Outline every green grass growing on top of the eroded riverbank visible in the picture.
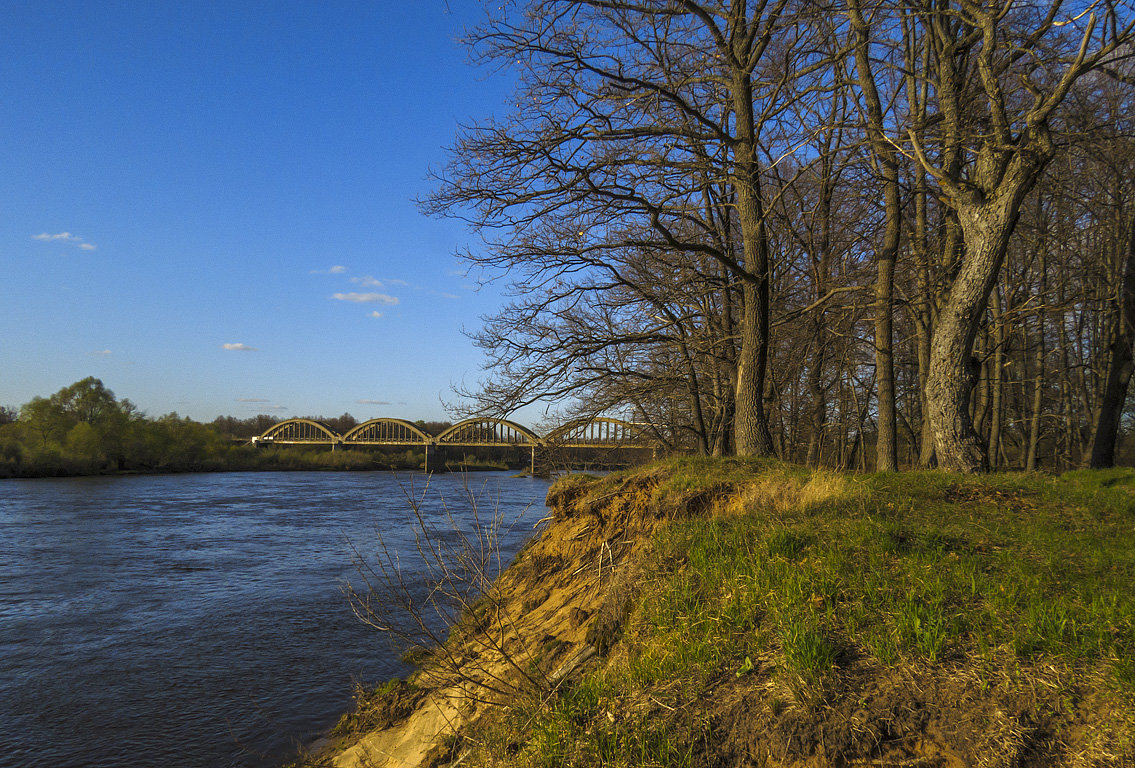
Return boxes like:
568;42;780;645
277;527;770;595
467;458;1135;767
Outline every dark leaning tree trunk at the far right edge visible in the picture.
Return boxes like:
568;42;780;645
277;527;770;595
1087;217;1135;470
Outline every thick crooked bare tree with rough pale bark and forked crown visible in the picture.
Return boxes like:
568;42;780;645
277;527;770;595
909;0;1133;472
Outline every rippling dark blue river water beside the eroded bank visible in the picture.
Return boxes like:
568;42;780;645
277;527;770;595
0;472;548;768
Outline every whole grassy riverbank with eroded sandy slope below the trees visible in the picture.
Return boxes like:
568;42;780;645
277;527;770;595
315;458;1135;767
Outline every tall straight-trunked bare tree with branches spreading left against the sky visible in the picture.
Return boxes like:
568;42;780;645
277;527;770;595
427;0;835;455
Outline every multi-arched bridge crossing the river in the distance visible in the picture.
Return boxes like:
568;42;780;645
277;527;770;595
251;416;657;472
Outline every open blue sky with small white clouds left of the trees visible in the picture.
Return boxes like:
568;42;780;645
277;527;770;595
0;0;526;420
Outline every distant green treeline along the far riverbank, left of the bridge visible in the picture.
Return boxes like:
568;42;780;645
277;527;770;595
0;377;483;478
